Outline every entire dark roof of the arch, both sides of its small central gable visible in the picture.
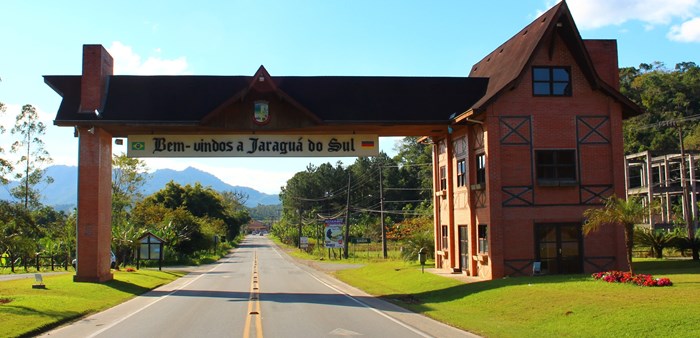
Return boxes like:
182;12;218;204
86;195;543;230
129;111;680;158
45;76;488;124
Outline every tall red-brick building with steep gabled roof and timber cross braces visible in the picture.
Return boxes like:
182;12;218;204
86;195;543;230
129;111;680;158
426;2;641;279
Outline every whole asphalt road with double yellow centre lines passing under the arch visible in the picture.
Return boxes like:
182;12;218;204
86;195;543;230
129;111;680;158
39;236;471;338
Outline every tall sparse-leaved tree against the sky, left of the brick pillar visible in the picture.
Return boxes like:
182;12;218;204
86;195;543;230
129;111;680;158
10;104;53;209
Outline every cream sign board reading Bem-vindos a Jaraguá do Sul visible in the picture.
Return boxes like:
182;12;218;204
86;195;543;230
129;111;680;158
127;135;379;157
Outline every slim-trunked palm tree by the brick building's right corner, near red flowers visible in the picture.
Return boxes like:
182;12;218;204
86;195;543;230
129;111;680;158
583;196;649;273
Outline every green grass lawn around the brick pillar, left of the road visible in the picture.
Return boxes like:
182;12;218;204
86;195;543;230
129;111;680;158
0;270;184;337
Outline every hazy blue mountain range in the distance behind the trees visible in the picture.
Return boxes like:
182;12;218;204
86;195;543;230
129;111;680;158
0;165;280;210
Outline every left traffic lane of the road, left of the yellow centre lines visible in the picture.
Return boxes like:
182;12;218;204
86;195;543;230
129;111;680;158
40;249;250;337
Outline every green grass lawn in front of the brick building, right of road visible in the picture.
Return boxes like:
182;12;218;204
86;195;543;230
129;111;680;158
336;260;700;337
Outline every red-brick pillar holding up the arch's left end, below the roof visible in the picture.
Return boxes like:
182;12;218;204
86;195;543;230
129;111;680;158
73;127;113;282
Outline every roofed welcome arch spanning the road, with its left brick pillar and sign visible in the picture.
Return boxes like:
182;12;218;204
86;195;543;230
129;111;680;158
44;45;488;282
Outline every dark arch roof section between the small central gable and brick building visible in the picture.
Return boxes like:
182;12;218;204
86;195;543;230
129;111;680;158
274;76;488;122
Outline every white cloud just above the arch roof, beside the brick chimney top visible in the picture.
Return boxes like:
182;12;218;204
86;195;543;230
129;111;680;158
107;41;190;75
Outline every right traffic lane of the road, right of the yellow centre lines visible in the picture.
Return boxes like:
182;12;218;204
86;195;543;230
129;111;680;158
256;238;430;337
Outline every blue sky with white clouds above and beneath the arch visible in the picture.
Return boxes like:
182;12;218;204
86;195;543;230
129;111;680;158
0;0;700;193
